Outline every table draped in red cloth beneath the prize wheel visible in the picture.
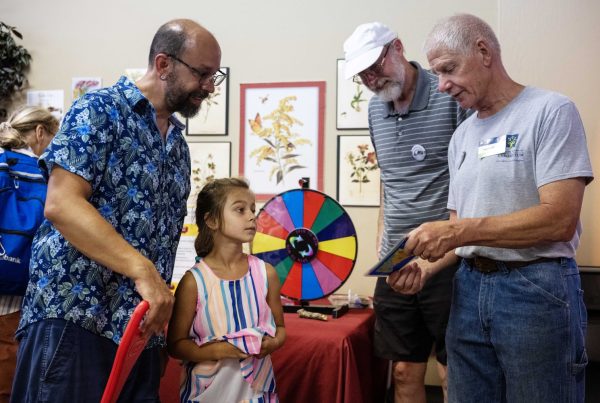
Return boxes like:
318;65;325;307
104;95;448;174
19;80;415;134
160;309;388;403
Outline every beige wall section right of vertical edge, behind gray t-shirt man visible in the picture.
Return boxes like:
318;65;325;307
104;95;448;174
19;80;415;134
498;0;600;266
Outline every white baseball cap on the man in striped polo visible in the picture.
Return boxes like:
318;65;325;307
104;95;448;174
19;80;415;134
344;22;398;79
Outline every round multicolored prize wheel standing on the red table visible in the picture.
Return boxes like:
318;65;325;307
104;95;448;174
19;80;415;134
252;189;358;301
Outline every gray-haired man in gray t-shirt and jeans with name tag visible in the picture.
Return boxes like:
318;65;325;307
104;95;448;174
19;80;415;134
390;14;593;403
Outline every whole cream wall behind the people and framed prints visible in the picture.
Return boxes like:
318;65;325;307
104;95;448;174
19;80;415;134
0;0;600;295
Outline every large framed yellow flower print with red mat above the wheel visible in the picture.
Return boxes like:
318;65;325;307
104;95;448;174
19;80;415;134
239;81;325;201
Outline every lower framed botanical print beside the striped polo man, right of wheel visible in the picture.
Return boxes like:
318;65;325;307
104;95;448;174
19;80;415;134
337;134;381;207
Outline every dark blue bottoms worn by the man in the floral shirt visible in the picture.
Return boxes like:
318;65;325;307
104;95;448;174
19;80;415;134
11;319;160;403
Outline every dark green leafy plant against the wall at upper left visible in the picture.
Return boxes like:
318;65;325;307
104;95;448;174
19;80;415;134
0;21;31;121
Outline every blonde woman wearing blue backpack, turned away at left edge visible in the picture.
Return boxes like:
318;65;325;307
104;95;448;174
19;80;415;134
0;106;59;403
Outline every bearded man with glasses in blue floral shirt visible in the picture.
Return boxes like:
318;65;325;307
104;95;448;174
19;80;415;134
12;20;224;402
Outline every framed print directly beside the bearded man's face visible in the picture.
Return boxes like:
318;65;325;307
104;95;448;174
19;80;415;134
186;67;231;136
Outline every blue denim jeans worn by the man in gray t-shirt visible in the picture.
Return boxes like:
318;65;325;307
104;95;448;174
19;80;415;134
446;258;587;403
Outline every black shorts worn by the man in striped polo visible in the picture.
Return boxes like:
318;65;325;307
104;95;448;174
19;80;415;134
373;266;458;365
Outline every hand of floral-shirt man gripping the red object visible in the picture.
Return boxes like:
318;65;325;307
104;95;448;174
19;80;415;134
132;260;175;337
